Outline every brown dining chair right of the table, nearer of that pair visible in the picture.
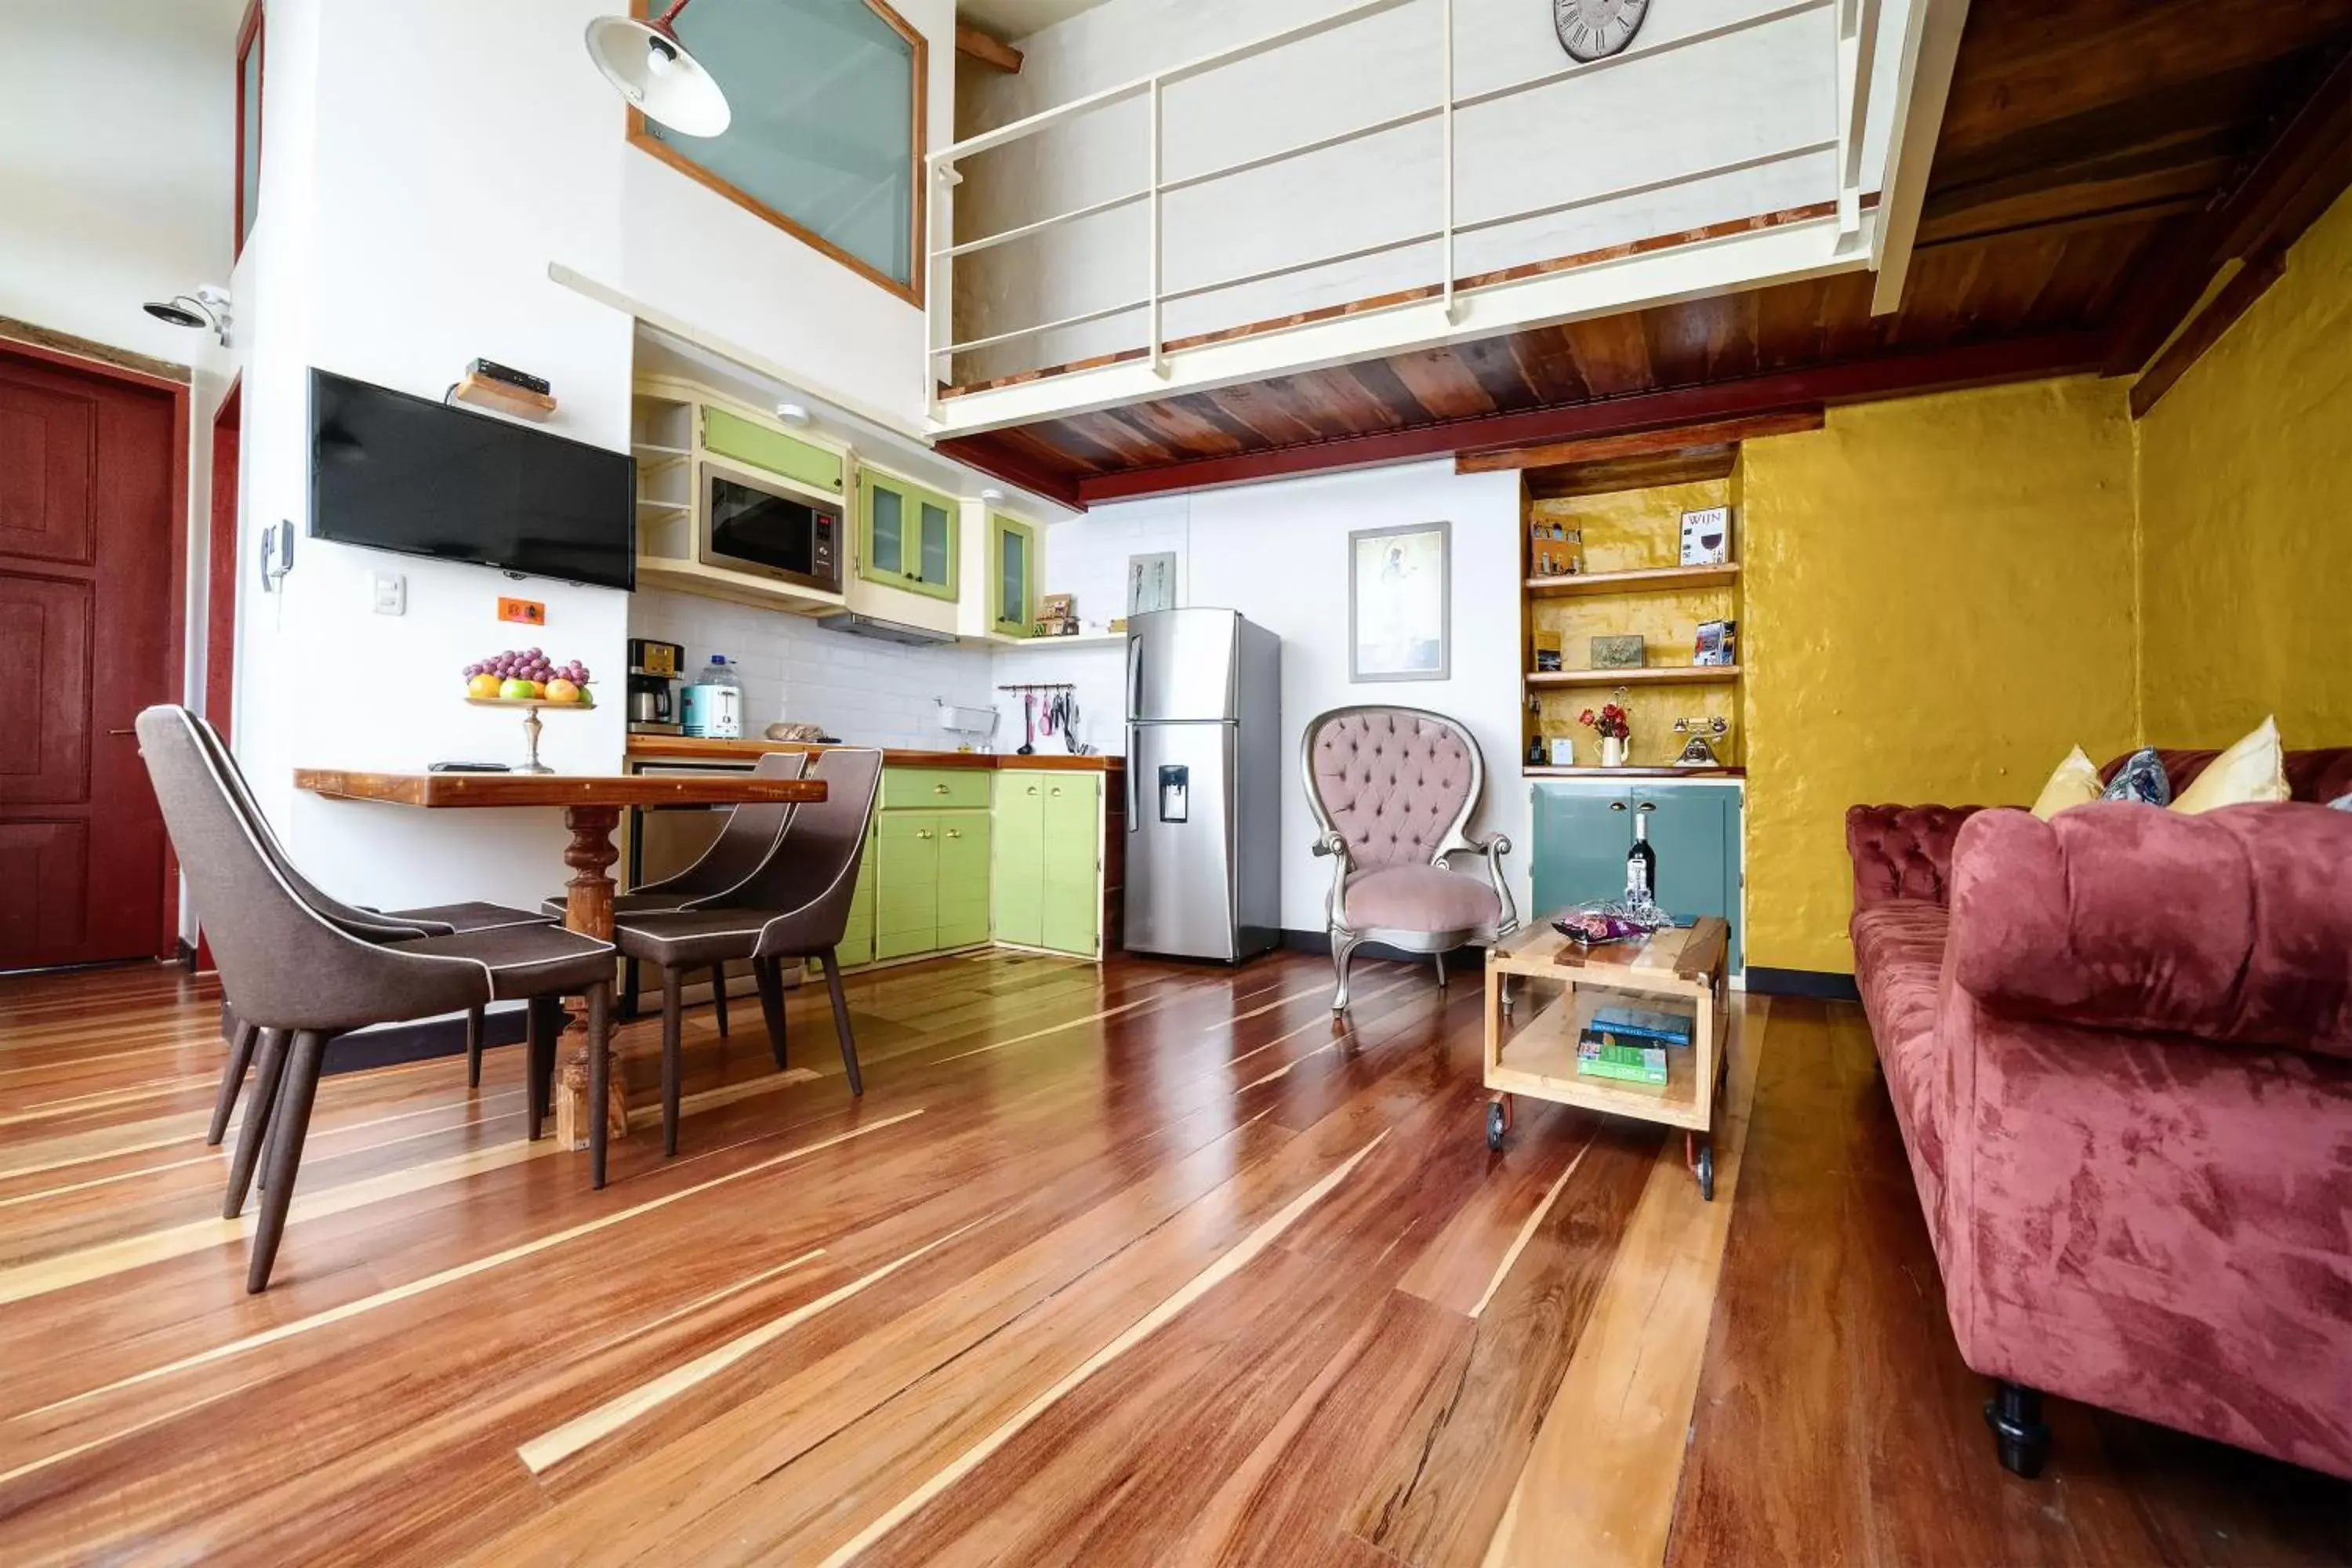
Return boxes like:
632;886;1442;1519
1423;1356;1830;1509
614;746;882;1154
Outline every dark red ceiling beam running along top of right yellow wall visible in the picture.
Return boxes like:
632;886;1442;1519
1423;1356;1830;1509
2103;49;2352;376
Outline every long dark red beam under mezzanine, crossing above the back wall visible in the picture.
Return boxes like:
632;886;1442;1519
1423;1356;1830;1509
1077;332;2105;506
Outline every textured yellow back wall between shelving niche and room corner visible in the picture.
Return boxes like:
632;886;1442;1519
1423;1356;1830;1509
1733;376;2145;971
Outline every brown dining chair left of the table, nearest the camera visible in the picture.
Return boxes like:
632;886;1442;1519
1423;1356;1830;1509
136;706;614;1293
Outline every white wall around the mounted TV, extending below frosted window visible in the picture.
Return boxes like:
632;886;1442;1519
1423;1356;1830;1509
209;0;969;931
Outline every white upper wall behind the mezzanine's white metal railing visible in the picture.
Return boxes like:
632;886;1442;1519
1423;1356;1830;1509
955;0;1905;379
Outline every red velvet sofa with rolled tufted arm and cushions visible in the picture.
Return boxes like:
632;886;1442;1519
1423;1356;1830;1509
1846;748;2352;1476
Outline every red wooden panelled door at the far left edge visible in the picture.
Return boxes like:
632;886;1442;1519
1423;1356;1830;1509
0;350;179;968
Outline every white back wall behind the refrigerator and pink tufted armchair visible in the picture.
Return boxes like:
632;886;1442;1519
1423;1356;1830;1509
995;461;1534;931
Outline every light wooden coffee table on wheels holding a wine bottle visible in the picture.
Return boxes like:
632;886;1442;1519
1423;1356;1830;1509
1486;914;1731;1203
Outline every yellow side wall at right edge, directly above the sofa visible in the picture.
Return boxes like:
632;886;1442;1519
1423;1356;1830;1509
2138;184;2352;750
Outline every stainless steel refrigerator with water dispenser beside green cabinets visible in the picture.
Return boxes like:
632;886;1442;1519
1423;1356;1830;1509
1127;609;1282;961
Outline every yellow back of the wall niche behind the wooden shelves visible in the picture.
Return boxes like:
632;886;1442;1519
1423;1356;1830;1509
1529;480;1740;767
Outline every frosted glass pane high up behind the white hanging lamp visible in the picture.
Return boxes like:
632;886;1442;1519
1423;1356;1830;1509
637;0;924;299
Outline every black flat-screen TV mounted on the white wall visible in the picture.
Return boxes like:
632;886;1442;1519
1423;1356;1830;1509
310;367;637;588
